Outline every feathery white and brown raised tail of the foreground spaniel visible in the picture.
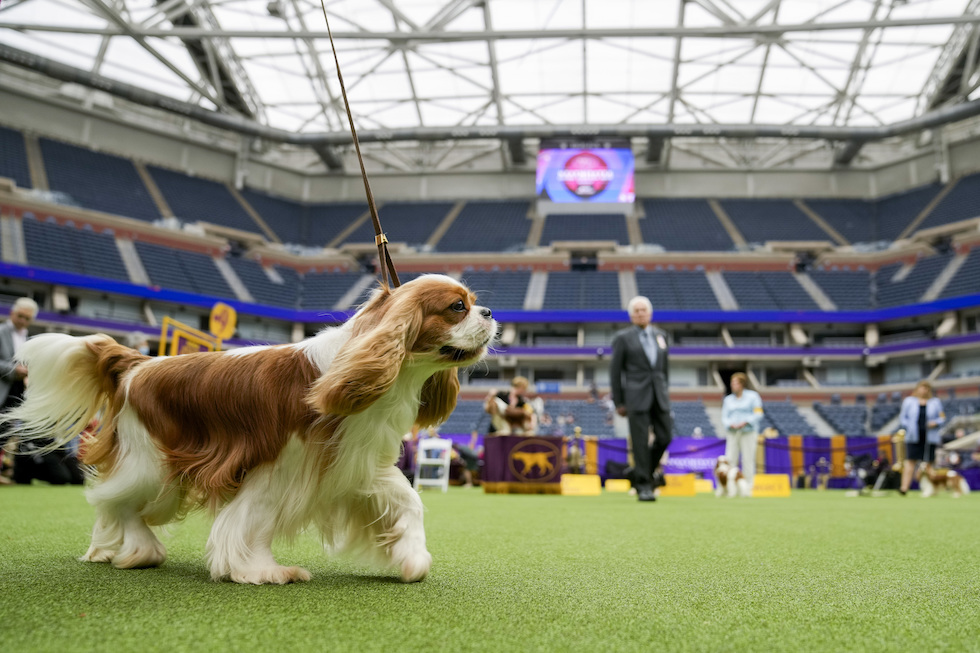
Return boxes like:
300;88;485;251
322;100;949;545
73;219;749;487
0;333;148;462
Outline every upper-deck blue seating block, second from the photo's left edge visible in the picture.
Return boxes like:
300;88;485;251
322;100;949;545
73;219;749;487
40;138;160;222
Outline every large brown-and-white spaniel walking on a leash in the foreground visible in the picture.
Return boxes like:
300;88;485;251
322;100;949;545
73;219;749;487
3;275;497;584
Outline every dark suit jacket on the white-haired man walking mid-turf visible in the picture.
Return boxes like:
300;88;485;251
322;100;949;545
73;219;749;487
609;325;670;412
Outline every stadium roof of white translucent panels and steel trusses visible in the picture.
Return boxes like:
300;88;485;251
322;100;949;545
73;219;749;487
0;0;980;173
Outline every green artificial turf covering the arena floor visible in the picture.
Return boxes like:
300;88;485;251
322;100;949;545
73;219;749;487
0;485;980;653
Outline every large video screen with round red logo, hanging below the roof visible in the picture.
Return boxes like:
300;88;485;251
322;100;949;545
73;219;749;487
536;140;636;203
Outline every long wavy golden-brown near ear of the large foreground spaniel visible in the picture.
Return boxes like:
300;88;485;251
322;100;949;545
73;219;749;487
306;292;422;415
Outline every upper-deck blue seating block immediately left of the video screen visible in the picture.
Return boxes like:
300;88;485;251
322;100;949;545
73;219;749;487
436;201;531;252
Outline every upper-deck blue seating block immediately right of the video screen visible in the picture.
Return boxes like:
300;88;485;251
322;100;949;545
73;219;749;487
639;199;735;252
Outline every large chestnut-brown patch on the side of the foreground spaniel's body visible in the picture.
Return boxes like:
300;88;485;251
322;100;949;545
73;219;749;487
129;347;322;504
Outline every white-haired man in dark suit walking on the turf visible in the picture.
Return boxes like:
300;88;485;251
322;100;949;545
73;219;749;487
609;297;673;501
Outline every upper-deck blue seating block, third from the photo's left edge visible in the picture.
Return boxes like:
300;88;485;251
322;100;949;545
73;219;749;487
146;166;262;234
